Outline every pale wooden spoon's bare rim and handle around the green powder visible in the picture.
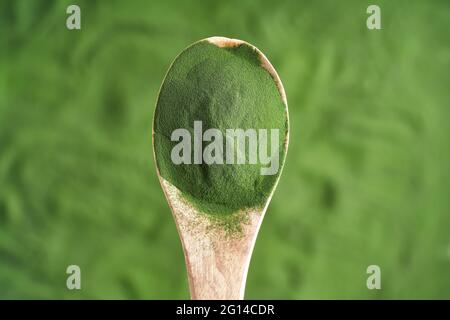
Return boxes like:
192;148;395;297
153;37;288;300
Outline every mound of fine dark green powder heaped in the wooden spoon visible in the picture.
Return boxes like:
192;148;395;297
154;41;288;219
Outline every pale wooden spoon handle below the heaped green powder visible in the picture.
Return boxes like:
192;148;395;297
174;210;262;300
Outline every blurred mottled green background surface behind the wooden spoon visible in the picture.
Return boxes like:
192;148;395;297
0;0;450;299
